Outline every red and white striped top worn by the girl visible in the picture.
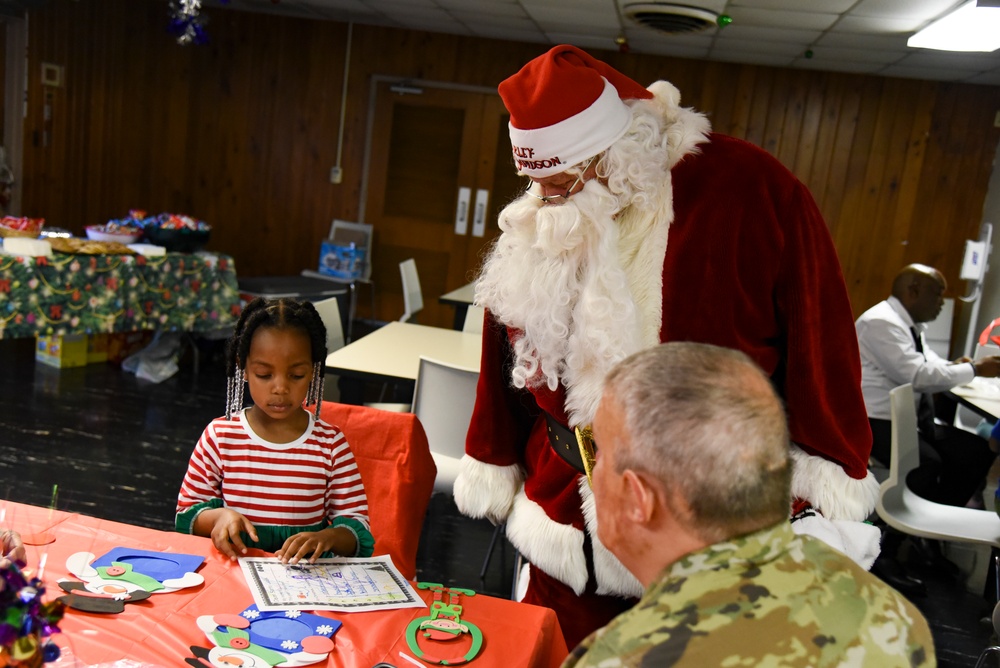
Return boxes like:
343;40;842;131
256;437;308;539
177;411;369;528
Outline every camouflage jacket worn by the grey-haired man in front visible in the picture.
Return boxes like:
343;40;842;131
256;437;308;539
563;522;937;668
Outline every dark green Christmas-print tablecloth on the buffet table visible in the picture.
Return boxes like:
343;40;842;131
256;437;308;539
0;253;240;339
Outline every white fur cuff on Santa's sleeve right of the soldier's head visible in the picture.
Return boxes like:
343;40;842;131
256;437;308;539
791;443;878;522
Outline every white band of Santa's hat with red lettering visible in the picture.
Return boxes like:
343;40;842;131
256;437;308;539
509;79;632;178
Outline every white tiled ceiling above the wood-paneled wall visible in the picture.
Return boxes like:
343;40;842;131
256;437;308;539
211;0;1000;85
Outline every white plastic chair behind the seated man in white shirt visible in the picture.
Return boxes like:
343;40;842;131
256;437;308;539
876;383;1000;548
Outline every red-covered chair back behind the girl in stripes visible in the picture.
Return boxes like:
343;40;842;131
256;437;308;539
320;401;437;580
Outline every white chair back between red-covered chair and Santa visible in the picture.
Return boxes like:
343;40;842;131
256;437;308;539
413;357;479;494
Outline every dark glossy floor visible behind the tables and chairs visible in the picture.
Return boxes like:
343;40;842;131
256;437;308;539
0;340;996;668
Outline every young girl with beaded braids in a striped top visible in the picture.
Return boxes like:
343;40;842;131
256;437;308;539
175;298;375;564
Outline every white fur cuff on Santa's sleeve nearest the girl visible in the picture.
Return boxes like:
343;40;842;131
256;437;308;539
453;455;524;524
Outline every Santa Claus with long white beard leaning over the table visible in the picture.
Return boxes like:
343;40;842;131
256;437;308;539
455;46;878;647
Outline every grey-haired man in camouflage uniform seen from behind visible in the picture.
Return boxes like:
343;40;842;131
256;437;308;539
563;343;936;668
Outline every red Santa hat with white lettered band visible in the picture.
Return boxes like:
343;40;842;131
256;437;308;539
500;45;653;178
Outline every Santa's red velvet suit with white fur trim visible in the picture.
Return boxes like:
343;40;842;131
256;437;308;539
455;47;878;647
